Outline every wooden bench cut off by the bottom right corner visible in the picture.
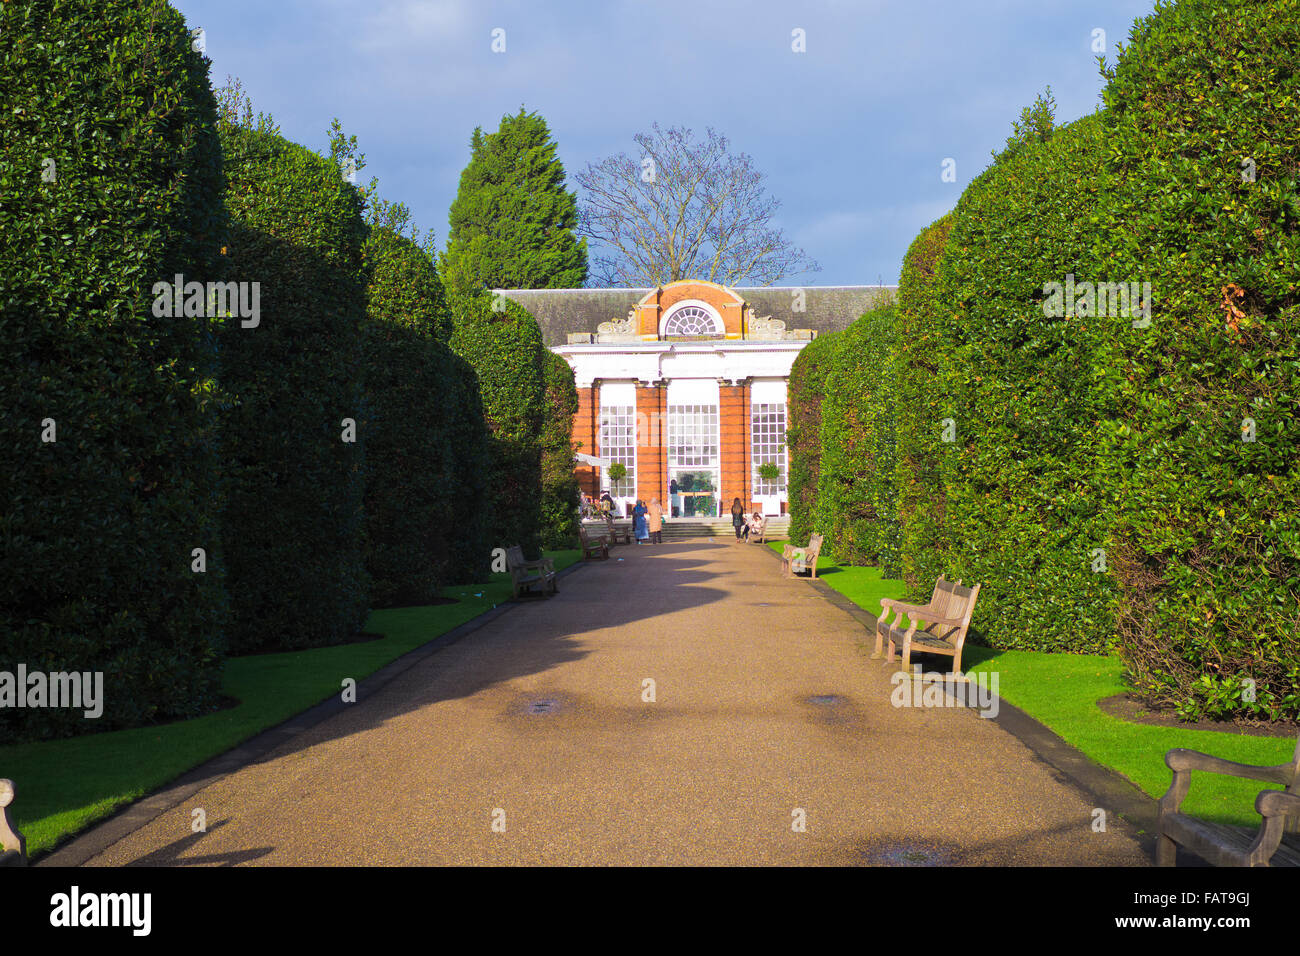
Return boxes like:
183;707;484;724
1156;739;1300;866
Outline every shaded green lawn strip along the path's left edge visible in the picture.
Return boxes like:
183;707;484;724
0;550;581;855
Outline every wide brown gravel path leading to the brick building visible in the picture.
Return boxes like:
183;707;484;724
83;540;1149;865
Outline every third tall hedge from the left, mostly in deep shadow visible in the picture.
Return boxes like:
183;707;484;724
364;226;482;607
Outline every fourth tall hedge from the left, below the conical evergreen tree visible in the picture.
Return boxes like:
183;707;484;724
450;293;546;554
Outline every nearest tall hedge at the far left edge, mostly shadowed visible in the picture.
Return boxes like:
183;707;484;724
0;0;225;739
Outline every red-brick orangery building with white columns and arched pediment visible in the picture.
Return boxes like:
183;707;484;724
499;280;896;518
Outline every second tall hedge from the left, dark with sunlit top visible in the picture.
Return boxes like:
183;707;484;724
221;124;369;652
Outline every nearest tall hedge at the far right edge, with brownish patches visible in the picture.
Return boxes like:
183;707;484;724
1104;0;1300;719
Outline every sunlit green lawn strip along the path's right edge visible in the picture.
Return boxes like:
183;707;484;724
771;541;1296;825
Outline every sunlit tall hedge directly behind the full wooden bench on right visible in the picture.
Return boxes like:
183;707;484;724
930;108;1114;653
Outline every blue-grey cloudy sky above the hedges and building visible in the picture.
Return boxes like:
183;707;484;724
172;0;1154;285
